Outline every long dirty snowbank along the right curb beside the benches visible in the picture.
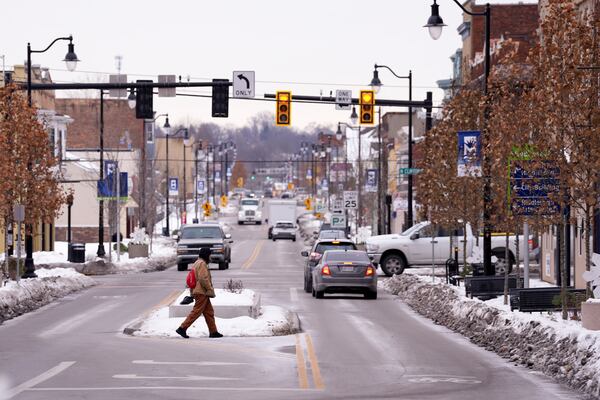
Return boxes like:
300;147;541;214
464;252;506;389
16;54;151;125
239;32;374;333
381;275;600;397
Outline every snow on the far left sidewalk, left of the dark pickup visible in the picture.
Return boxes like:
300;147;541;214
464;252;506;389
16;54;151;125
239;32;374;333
33;236;177;275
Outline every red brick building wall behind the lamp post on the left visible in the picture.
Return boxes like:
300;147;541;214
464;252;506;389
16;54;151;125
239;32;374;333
56;99;144;149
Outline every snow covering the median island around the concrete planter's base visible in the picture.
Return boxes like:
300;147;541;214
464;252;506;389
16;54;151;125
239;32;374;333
134;306;298;338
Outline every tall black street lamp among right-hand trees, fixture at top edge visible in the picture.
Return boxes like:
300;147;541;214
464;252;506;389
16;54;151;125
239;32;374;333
425;0;495;275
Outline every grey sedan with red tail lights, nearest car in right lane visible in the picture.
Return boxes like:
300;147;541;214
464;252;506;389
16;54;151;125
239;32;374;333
311;250;377;299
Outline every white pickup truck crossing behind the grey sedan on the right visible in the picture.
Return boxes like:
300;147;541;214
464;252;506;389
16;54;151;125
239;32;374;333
366;221;531;276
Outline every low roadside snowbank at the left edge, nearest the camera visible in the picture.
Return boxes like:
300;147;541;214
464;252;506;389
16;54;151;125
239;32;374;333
0;268;95;323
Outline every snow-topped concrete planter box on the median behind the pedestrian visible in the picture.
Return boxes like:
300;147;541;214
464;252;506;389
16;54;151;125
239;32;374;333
169;289;260;319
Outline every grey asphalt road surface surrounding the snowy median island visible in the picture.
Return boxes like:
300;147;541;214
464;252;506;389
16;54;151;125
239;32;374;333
0;214;580;400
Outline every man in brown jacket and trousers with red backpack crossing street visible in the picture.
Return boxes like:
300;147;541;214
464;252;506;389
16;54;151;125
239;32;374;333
175;247;223;339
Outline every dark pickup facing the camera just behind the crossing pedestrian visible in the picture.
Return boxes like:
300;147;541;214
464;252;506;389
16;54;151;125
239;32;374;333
177;223;233;271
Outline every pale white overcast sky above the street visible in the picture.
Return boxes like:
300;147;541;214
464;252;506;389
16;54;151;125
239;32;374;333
0;0;540;127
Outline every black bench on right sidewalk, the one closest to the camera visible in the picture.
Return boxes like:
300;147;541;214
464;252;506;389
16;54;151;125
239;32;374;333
510;287;585;312
